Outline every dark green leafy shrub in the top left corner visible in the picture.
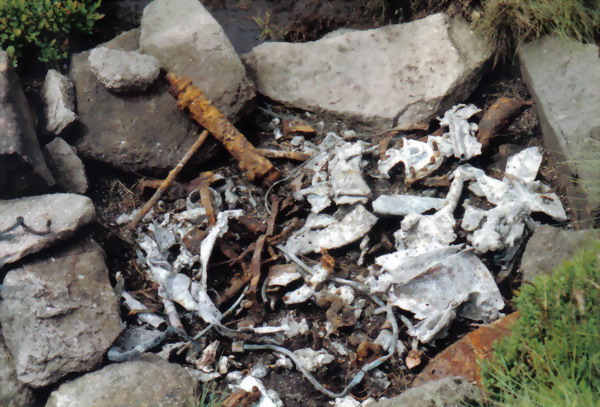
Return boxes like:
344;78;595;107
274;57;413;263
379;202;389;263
0;0;102;62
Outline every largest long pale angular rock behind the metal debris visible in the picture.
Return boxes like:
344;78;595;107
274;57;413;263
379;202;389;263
243;14;490;129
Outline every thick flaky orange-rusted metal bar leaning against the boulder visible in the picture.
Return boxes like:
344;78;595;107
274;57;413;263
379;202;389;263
167;73;281;185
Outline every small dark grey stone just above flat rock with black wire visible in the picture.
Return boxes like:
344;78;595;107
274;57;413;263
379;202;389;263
44;137;88;194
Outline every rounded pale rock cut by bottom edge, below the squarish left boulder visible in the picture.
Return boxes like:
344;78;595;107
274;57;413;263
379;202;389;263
46;354;195;407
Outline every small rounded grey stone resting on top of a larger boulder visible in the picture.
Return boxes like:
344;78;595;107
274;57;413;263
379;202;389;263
88;47;160;92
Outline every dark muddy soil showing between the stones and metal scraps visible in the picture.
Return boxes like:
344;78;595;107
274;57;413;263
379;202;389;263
20;0;566;407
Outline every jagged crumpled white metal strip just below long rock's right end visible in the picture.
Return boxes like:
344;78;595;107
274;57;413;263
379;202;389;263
377;104;481;184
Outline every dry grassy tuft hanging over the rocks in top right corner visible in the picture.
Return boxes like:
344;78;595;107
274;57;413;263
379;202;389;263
473;0;600;60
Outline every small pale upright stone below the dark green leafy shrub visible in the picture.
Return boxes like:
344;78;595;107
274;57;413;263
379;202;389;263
42;69;77;135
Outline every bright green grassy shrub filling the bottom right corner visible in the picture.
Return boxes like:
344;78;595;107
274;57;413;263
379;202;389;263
482;241;600;407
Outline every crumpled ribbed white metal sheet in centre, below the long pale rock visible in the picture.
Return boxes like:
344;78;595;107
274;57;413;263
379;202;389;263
294;139;371;213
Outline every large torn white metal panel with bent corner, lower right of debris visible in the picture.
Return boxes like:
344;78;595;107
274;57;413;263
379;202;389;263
390;251;504;342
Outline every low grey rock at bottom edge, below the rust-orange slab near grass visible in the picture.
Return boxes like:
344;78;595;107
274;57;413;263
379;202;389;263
369;377;483;407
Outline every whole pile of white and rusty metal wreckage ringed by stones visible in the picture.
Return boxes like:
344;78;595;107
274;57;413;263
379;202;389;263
109;105;567;407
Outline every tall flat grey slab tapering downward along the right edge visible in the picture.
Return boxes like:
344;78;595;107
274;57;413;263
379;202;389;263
519;37;600;220
